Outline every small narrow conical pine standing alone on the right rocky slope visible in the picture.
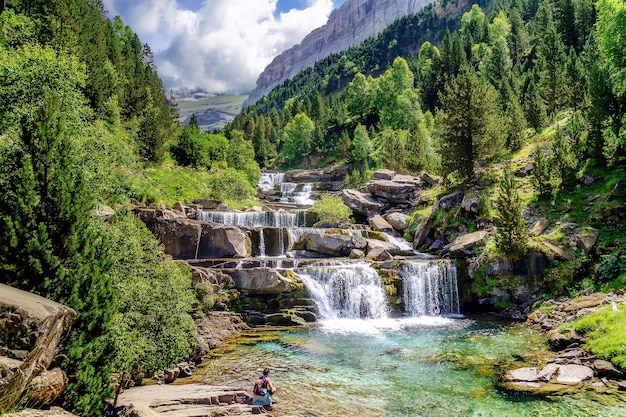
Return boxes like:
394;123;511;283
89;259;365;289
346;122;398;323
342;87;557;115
495;162;527;254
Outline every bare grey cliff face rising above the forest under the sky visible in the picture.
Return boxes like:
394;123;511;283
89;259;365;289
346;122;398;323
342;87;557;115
243;0;434;107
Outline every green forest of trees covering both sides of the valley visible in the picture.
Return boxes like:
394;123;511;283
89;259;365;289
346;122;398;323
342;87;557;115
0;0;626;416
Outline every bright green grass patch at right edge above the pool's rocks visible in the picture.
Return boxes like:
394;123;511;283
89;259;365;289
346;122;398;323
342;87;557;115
561;304;626;368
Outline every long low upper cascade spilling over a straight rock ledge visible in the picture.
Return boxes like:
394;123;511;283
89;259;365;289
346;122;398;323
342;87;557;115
198;210;306;228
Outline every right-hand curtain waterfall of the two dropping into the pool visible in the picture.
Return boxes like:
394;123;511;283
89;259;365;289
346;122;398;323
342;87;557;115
400;260;460;316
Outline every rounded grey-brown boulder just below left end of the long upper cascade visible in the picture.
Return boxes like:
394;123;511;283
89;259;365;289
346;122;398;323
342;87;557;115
196;222;252;259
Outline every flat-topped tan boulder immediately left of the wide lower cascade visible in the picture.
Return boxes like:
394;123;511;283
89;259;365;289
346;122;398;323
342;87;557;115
224;267;295;295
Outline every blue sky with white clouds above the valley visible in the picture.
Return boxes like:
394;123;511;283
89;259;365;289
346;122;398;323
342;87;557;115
103;0;346;94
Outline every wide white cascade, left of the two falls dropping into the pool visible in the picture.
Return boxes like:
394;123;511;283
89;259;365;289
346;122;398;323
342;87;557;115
297;263;389;320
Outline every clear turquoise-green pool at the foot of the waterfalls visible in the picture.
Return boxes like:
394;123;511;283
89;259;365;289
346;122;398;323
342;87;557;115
197;318;626;417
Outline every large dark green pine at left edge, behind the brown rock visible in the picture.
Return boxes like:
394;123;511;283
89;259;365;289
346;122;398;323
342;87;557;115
0;96;115;416
